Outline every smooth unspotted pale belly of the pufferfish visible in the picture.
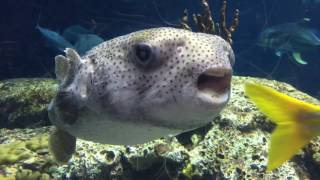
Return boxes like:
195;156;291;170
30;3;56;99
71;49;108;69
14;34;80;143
67;118;181;145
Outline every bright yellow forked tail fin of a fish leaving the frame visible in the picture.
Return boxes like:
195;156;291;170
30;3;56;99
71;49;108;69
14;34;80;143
245;84;320;171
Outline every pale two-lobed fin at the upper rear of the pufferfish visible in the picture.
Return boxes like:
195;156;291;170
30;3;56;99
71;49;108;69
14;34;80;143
55;48;81;85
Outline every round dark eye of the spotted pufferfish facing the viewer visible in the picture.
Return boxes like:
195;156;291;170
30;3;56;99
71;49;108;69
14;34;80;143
135;43;153;66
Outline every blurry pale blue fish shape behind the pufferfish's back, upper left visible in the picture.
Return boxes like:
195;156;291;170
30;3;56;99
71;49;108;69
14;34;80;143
36;25;104;55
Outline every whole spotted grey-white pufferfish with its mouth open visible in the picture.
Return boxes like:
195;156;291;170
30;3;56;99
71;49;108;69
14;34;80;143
48;28;235;163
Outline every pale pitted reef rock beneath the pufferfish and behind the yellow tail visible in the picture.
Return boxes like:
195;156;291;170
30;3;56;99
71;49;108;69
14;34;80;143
0;77;320;179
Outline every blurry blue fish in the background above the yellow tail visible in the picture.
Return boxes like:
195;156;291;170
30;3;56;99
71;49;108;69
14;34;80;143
258;18;320;65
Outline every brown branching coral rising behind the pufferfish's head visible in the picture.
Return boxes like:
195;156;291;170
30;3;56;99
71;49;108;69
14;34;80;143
180;0;240;44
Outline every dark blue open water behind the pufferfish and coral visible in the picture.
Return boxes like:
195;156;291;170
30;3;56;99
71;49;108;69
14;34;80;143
0;0;320;98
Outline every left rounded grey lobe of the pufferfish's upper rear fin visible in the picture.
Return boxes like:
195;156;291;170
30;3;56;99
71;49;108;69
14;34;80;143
55;55;70;82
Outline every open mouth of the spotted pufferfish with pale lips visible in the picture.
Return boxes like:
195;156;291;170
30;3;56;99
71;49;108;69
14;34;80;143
197;68;232;95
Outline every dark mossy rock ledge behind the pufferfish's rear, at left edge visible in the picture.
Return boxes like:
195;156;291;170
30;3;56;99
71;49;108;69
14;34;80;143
0;78;58;128
